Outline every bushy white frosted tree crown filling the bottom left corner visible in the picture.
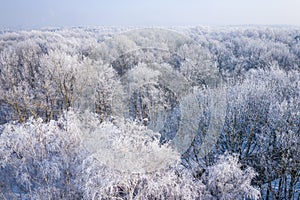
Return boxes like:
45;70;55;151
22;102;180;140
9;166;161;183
0;113;86;199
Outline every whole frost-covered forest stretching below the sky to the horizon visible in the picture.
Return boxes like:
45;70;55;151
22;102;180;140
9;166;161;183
0;26;300;200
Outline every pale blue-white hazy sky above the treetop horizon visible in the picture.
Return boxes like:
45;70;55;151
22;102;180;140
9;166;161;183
0;0;300;29
